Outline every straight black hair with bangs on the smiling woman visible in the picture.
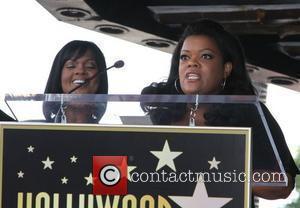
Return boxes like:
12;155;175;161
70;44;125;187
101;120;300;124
43;40;108;123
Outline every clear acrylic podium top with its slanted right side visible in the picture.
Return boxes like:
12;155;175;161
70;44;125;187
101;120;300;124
5;94;287;186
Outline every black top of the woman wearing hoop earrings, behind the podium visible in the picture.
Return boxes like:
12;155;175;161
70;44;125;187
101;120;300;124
141;103;300;177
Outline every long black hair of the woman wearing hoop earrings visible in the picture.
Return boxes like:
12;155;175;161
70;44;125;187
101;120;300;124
141;19;255;124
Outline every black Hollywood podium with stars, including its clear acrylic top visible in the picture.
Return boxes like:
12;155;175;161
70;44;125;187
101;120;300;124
0;94;287;208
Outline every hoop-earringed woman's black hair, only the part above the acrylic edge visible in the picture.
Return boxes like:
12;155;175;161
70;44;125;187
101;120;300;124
142;19;254;95
